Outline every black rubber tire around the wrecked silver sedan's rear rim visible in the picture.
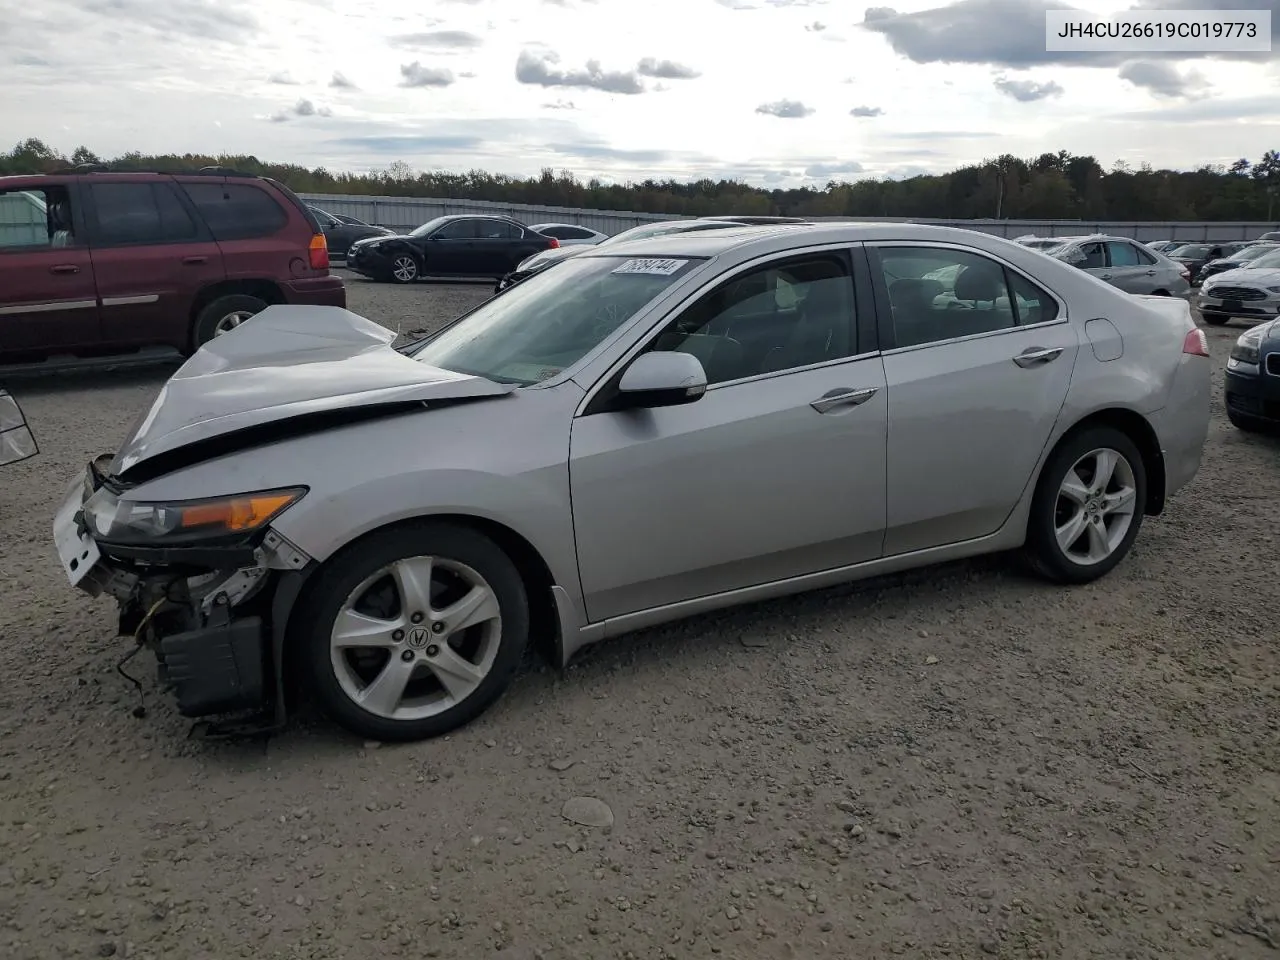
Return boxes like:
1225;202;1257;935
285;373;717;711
1023;426;1147;584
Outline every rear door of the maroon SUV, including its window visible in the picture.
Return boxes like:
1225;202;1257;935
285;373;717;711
84;175;225;348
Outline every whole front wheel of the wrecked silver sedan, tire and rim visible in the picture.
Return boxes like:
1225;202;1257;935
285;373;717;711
297;522;529;741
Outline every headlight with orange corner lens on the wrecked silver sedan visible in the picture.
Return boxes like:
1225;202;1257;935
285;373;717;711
84;486;307;547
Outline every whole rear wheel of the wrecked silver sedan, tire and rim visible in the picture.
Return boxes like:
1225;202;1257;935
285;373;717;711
1025;426;1147;584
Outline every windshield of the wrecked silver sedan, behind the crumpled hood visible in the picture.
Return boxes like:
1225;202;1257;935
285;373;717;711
412;256;700;387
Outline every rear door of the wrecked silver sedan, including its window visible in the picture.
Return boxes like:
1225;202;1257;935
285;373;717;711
872;243;1079;557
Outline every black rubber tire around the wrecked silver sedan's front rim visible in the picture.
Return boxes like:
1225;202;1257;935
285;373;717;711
291;521;529;742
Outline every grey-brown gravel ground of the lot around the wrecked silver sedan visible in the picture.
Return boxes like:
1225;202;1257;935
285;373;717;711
0;271;1280;960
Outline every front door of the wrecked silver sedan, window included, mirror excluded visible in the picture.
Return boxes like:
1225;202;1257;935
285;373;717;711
570;251;886;621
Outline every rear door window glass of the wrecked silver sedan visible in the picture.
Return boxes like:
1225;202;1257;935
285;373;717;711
879;247;1057;347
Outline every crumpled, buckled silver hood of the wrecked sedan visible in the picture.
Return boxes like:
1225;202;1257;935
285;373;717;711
110;306;515;475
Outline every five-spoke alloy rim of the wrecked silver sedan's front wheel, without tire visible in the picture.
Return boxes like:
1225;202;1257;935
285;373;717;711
329;557;502;721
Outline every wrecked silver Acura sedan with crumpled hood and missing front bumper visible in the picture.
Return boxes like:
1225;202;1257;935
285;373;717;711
54;223;1211;740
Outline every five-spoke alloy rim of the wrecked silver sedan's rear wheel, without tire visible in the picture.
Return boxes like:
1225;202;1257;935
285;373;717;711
1053;447;1138;566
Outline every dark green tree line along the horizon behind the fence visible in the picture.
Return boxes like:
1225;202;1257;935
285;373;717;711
0;138;1280;221
